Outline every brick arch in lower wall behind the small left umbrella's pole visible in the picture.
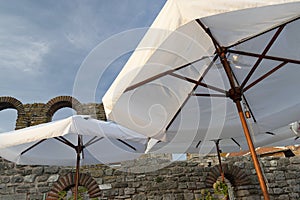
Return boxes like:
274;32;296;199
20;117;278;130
46;173;101;200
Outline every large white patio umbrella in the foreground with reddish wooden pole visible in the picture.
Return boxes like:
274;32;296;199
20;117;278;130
103;0;300;199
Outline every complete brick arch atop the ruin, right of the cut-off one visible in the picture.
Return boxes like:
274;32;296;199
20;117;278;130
46;96;82;119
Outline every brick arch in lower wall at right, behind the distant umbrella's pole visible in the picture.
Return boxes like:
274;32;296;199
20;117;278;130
205;164;250;187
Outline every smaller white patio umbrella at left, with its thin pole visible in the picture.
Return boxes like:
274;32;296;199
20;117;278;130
0;115;148;199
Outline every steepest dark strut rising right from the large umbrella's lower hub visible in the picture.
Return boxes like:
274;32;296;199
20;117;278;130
241;24;285;88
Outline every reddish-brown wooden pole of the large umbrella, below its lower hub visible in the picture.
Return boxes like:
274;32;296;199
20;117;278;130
235;101;270;200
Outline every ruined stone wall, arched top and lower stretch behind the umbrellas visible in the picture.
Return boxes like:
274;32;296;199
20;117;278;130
0;96;300;200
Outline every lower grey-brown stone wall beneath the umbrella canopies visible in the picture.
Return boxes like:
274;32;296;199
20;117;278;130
0;157;300;200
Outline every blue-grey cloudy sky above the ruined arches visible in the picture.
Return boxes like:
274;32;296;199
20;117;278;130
0;0;166;132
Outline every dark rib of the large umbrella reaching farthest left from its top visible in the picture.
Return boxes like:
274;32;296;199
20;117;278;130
124;56;207;93
